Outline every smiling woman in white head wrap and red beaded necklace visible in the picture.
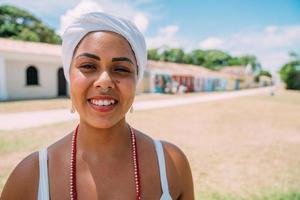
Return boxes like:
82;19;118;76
1;13;194;200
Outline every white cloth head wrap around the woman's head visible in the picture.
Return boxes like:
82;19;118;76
62;12;147;86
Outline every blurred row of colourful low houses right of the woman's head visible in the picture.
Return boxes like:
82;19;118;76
139;61;256;93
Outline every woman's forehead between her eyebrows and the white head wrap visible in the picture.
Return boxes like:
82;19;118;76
74;31;134;58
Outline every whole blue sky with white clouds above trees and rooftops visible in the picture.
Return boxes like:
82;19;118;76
0;0;300;73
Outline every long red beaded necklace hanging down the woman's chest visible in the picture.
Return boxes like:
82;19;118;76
70;125;141;200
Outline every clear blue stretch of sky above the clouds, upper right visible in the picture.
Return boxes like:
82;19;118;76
157;0;300;37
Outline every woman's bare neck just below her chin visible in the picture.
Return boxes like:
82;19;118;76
77;118;131;157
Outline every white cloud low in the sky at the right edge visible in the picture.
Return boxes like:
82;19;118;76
199;25;300;72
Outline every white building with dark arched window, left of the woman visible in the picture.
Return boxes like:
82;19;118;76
0;38;68;101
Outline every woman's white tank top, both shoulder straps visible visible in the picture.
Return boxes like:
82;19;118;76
38;140;172;200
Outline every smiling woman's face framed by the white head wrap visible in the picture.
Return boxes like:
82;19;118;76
70;32;137;128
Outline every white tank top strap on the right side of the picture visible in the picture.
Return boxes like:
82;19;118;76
154;140;171;200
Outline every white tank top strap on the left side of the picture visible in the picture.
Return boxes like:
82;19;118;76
38;149;49;200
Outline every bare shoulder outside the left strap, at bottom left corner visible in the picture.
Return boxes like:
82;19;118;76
1;152;39;200
